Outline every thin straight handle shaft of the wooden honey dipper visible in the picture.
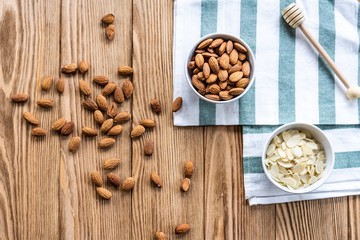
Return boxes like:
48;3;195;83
299;24;350;89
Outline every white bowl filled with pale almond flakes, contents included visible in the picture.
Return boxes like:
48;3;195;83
262;122;335;193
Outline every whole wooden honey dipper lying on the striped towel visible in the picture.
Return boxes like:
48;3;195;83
282;3;360;99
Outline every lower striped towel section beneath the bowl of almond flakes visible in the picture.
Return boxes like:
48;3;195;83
243;125;360;205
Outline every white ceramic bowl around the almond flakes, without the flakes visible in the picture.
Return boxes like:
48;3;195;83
262;122;335;193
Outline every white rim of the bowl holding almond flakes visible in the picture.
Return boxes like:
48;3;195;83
261;122;335;194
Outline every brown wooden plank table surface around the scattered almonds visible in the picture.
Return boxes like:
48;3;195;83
0;0;360;240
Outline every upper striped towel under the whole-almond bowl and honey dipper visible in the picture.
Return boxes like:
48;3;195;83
173;0;360;126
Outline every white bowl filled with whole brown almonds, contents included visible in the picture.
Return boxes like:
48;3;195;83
185;33;255;104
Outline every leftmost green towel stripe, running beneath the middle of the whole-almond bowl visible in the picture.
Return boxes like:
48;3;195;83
199;0;218;125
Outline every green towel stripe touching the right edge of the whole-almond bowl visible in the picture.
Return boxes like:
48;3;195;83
239;0;257;124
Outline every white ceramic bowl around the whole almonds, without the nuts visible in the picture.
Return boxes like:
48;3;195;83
185;33;255;104
